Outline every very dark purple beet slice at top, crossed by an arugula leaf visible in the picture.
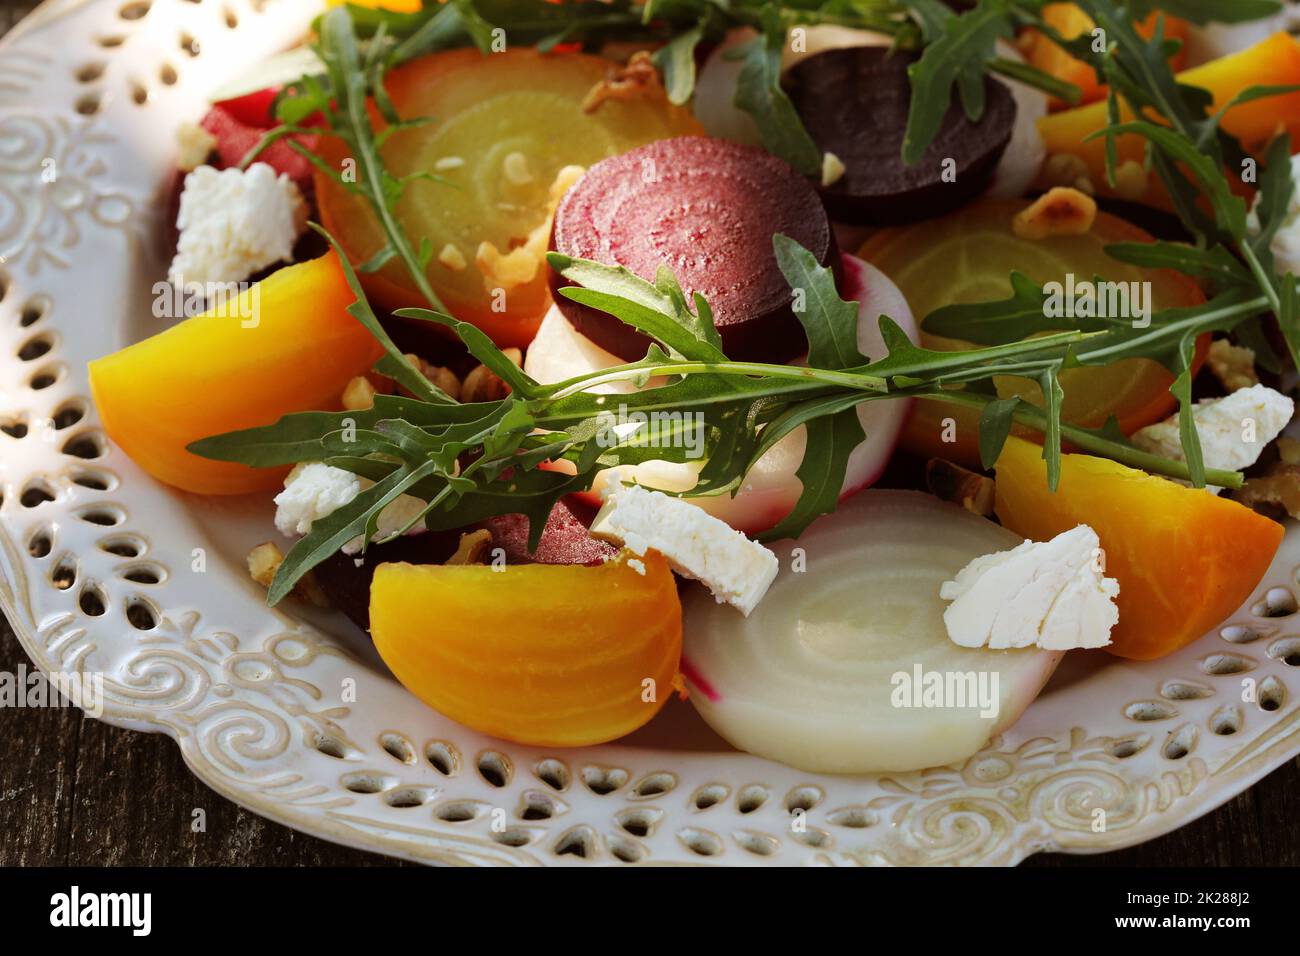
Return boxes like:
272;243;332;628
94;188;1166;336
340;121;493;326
781;47;1015;225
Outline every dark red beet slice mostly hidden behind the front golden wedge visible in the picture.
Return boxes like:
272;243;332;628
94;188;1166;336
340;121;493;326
315;499;618;631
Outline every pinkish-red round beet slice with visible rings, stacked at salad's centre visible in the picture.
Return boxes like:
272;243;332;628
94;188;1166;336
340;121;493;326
551;137;839;362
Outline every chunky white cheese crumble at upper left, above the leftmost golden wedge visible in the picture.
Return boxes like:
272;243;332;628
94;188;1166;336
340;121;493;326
168;163;307;287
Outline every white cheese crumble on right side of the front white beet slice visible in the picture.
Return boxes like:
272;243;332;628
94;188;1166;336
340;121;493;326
939;524;1119;650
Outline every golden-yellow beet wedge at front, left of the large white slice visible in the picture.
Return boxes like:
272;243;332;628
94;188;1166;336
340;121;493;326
371;551;681;747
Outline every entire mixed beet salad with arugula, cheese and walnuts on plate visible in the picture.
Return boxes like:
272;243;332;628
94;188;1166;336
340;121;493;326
90;0;1300;773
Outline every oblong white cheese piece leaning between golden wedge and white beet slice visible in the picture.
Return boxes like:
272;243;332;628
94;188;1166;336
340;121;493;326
592;481;780;617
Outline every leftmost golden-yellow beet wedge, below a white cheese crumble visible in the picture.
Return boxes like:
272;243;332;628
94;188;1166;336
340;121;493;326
90;252;381;494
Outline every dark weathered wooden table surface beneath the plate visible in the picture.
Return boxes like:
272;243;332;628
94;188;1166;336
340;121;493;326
0;0;1300;866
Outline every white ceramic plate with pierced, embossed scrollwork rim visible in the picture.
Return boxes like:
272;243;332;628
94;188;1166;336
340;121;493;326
0;0;1300;865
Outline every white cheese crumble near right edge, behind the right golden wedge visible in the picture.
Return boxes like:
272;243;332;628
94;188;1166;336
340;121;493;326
1132;385;1295;494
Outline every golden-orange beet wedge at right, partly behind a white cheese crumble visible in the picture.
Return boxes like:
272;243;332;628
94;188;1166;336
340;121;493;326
996;437;1283;661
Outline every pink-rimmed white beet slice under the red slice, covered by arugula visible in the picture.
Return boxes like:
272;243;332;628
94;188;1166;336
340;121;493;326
524;256;918;535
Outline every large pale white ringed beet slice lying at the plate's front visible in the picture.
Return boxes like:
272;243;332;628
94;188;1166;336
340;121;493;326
681;490;1063;774
